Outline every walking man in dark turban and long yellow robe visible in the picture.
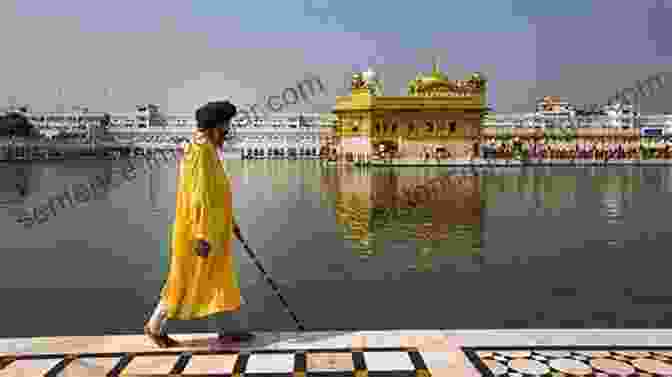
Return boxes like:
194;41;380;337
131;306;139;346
144;101;251;348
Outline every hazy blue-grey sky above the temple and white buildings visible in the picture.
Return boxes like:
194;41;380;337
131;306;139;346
0;0;672;113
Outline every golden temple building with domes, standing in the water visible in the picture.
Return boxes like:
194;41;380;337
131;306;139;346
333;63;487;158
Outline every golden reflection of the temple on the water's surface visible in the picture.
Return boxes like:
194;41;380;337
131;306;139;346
322;169;483;270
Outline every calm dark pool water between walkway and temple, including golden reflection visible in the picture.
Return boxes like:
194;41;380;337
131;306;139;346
0;160;672;337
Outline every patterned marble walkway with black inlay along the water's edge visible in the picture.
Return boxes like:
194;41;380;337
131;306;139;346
0;329;672;377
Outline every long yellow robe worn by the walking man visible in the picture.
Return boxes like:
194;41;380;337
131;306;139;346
161;139;241;319
